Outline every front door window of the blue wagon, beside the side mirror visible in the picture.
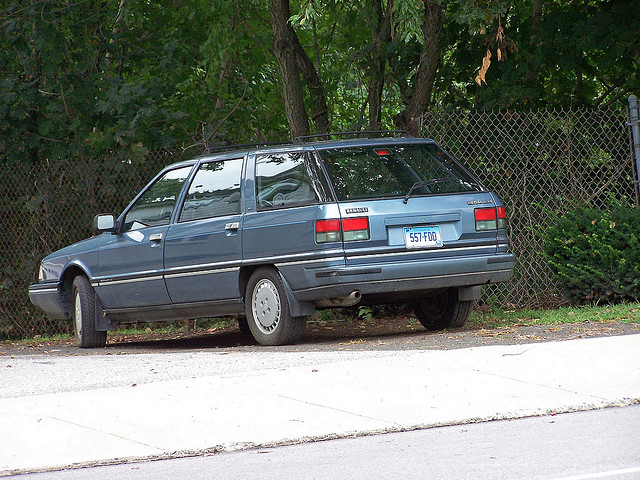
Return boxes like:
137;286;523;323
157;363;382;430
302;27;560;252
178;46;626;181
122;165;193;232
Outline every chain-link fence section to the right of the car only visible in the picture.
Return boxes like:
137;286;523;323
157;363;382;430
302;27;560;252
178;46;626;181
424;106;638;308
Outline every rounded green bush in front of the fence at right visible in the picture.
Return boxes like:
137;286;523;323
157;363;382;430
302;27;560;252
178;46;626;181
542;201;640;304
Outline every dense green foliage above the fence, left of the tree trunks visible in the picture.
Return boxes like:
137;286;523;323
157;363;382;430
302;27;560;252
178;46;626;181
0;0;286;163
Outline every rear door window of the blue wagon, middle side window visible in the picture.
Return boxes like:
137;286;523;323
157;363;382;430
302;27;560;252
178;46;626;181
180;158;242;222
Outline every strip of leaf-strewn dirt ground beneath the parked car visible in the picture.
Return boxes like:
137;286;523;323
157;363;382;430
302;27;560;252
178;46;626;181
0;315;640;356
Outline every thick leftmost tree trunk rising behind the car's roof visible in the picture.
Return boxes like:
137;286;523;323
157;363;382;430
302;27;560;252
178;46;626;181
269;0;309;138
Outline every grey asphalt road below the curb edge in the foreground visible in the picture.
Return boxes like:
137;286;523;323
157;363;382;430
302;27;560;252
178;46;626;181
15;406;640;480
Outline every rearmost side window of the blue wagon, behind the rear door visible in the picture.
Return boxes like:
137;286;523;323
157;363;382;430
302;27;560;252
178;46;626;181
256;152;324;210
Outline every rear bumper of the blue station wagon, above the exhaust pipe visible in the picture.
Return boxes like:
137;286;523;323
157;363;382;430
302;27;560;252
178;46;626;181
294;253;515;302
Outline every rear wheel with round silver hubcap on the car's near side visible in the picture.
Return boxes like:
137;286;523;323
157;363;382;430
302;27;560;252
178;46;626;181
245;268;306;345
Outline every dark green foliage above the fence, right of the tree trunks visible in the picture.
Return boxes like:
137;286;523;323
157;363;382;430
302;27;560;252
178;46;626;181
436;0;640;110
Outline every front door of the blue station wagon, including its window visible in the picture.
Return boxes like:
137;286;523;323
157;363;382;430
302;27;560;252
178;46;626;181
96;165;193;309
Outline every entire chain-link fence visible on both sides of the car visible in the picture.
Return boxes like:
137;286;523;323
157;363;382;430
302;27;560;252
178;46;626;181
0;106;637;339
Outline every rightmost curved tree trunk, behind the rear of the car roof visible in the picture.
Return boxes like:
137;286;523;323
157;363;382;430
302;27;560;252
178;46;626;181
394;0;442;137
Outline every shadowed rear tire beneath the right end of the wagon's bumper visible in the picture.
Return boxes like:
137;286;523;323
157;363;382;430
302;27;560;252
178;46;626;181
413;288;473;330
